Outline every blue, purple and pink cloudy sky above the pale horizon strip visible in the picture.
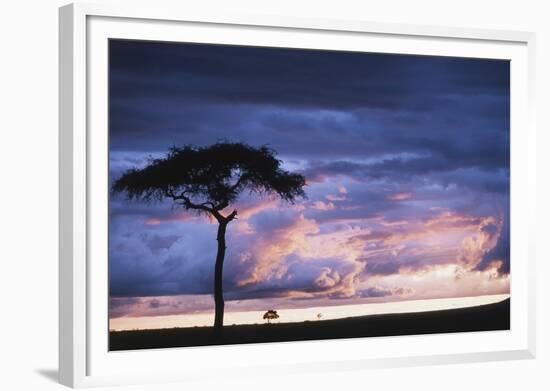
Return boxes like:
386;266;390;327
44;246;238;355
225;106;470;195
109;40;510;324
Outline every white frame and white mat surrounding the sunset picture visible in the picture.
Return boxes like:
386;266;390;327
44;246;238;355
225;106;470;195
59;4;536;387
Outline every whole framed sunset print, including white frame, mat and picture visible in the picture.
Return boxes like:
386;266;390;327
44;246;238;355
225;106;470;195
60;5;535;387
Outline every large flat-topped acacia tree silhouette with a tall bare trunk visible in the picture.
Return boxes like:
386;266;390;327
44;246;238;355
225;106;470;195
112;142;306;332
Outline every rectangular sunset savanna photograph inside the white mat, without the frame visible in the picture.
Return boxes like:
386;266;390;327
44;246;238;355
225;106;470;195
108;38;518;351
